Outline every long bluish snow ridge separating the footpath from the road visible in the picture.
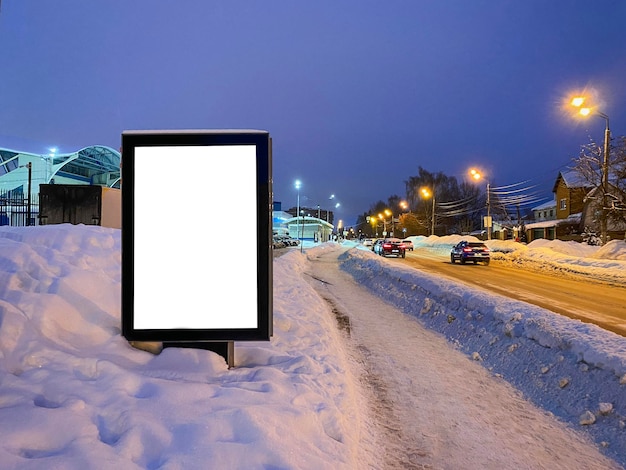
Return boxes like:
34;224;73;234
340;249;626;464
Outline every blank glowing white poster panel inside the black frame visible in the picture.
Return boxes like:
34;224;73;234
133;145;258;330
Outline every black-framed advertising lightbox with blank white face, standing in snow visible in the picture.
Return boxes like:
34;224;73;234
122;130;272;342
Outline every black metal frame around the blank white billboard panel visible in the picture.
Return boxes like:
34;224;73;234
122;130;273;365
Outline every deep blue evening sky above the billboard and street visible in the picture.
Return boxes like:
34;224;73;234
0;0;626;226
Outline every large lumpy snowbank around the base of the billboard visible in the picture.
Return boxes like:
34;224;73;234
0;225;362;470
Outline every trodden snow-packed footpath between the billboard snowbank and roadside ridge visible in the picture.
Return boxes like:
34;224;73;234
305;250;619;470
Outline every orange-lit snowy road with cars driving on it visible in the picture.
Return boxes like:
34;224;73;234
400;249;626;337
